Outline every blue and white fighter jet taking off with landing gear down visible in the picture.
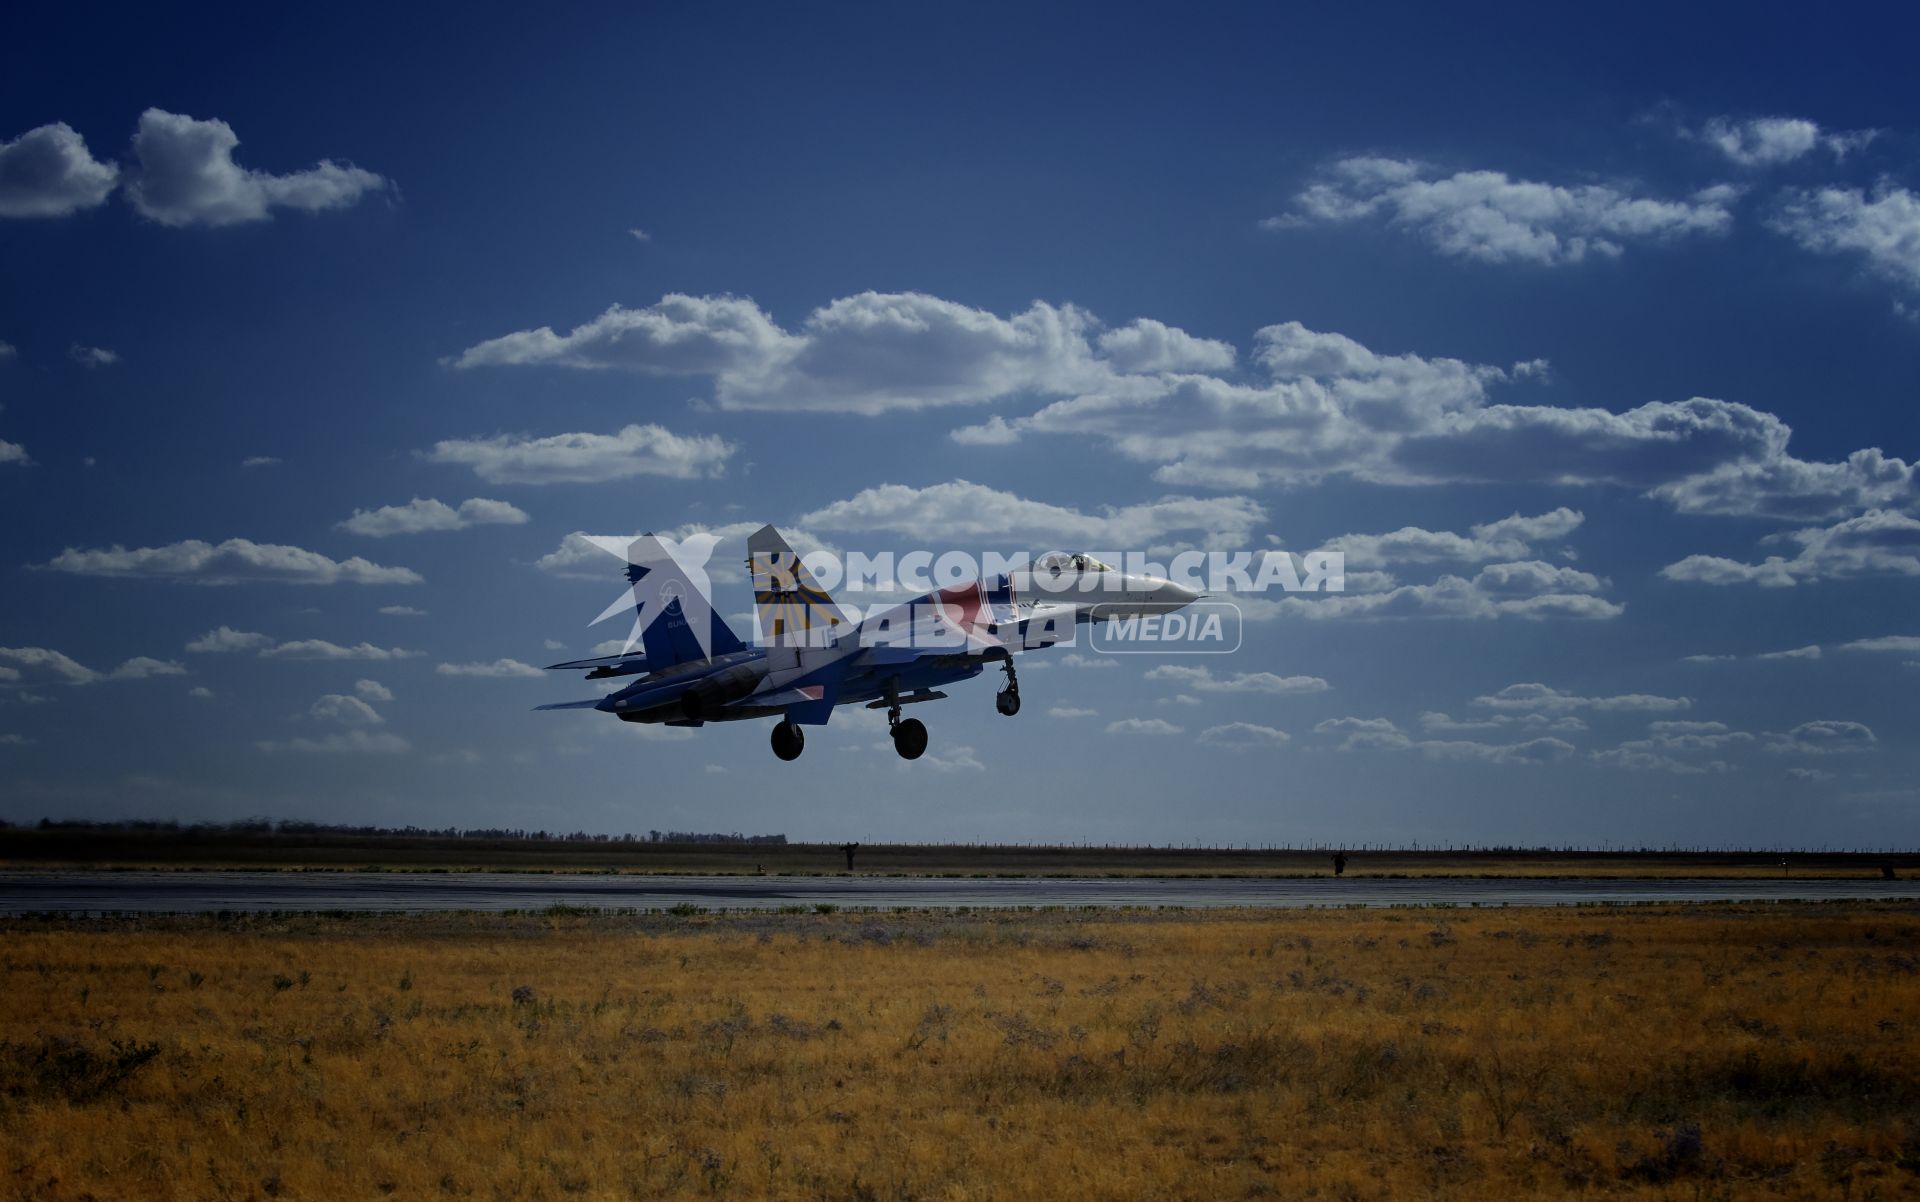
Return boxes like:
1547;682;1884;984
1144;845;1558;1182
538;526;1198;760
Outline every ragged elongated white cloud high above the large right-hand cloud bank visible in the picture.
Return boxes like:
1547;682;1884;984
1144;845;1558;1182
1263;157;1736;267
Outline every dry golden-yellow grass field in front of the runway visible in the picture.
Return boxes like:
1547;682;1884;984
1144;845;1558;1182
0;904;1920;1202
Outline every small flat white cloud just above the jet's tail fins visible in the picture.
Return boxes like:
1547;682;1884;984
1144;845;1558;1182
420;424;735;484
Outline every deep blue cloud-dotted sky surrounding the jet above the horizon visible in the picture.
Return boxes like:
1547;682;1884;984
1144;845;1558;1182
0;6;1920;847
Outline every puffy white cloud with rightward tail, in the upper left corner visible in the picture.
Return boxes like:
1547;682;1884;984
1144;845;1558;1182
127;109;388;227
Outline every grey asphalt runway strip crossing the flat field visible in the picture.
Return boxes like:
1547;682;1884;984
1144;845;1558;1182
0;872;1920;914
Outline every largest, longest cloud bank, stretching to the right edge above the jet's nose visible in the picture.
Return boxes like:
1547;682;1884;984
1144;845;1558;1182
956;323;1920;518
